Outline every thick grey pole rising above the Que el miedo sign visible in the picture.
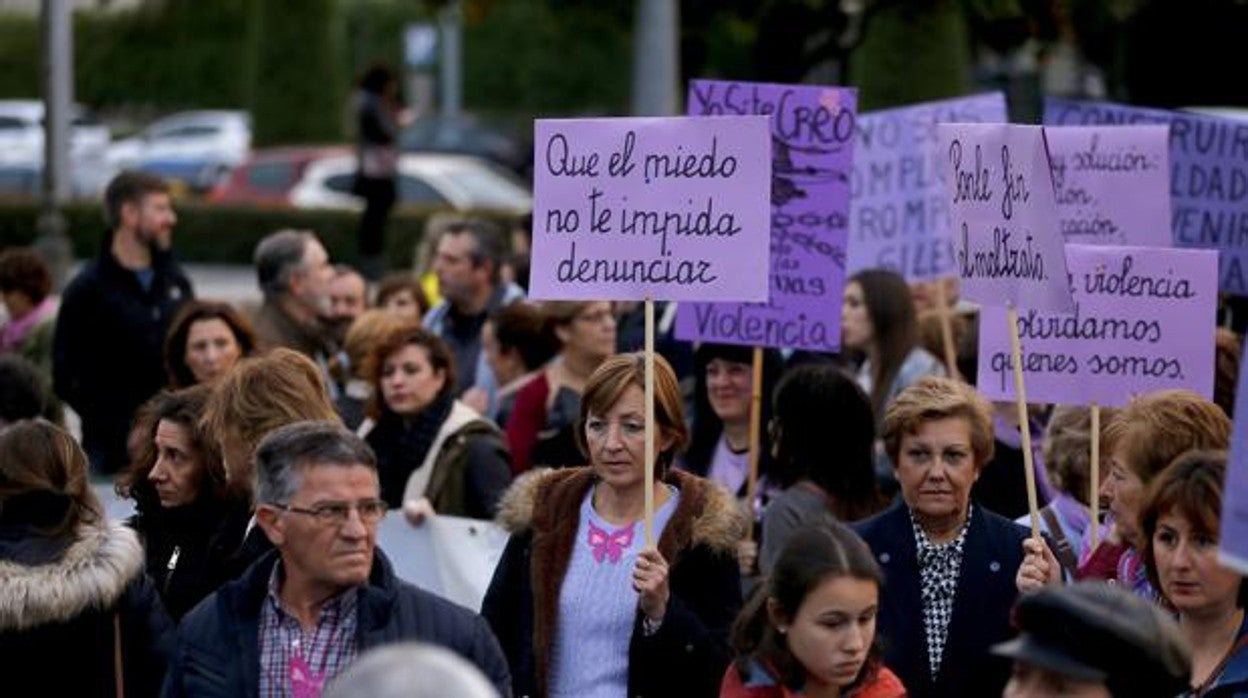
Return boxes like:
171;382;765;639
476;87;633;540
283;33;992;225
633;0;680;116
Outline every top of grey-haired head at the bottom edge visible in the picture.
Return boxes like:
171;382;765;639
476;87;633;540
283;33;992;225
324;642;498;698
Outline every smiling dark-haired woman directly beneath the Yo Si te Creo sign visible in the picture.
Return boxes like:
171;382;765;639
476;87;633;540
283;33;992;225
684;343;784;496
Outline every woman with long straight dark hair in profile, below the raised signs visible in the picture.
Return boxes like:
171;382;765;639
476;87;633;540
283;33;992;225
841;268;945;423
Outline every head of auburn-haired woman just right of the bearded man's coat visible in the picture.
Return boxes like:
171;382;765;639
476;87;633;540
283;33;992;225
165;300;256;388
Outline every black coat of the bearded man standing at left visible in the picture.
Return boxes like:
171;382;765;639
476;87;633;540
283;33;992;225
52;242;193;472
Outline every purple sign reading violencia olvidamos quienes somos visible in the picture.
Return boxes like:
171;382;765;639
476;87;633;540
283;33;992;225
976;245;1218;406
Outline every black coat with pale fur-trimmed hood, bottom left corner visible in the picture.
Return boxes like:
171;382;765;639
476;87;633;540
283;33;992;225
0;523;173;698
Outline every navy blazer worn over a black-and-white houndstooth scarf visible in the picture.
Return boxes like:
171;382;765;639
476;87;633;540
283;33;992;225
854;498;1028;698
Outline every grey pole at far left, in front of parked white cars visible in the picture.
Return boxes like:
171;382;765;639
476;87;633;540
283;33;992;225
35;0;74;288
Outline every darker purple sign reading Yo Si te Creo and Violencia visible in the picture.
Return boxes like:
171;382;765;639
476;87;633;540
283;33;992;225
676;80;857;351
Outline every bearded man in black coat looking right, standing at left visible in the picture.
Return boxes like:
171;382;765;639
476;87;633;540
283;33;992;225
52;172;193;473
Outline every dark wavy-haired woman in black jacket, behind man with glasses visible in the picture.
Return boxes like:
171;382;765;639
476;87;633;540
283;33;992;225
117;385;251;621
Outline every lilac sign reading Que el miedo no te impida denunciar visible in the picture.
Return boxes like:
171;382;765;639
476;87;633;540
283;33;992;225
529;116;771;301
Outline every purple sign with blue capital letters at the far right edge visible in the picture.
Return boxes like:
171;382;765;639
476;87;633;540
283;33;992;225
1045;99;1248;296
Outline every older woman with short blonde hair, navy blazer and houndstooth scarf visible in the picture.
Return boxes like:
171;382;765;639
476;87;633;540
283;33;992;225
855;377;1027;697
